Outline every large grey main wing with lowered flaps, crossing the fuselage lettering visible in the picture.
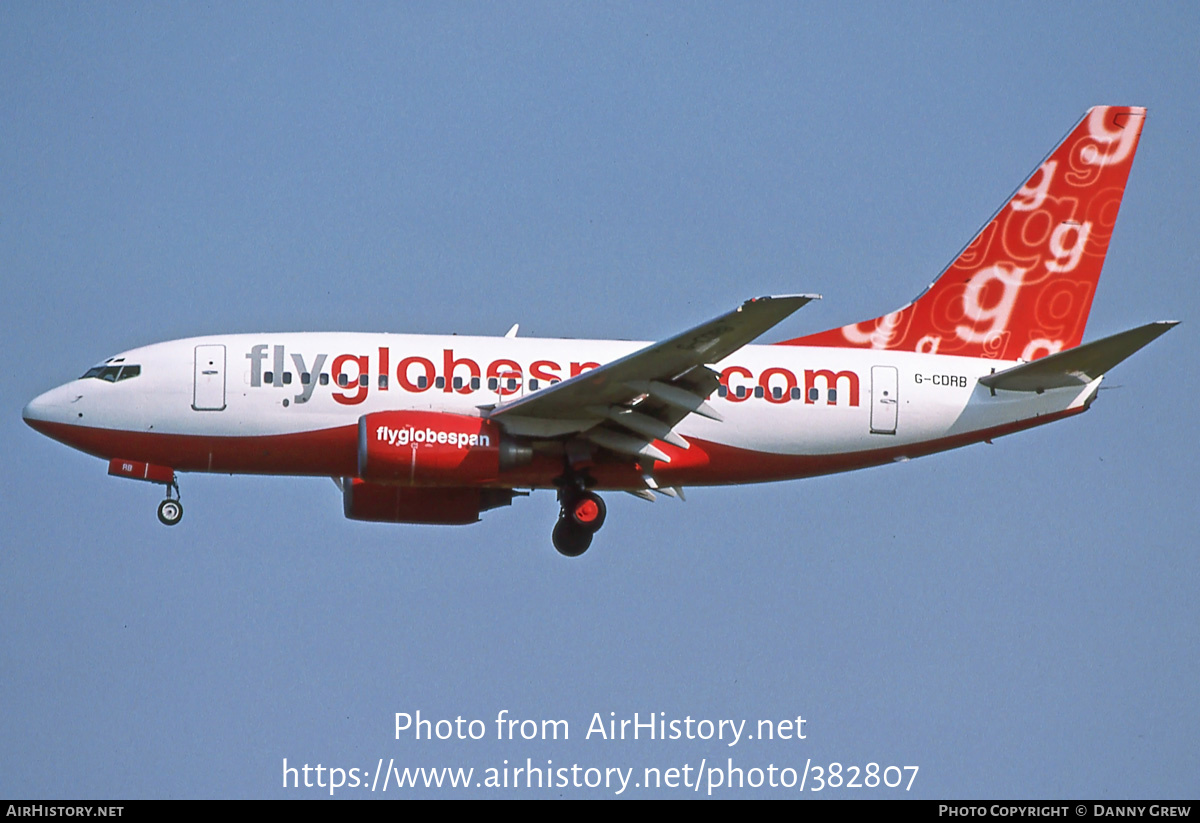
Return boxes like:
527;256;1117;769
486;294;820;462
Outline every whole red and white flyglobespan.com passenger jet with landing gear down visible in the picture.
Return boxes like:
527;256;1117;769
23;107;1176;557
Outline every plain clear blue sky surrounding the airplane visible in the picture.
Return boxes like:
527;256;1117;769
0;2;1200;798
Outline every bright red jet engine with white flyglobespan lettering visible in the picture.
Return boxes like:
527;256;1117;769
359;412;533;486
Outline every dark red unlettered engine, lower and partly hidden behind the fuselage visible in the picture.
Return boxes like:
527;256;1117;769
342;479;514;525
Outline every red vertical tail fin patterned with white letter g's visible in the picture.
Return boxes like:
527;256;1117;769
785;106;1146;360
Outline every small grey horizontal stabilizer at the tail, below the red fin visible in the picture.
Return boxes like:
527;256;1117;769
979;320;1178;391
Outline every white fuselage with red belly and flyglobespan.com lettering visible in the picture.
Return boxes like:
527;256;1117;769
25;332;1099;488
